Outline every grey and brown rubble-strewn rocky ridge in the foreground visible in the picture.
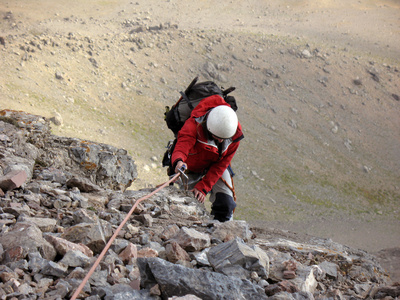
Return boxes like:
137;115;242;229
0;110;400;300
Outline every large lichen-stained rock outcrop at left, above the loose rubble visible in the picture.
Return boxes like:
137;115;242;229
0;110;137;190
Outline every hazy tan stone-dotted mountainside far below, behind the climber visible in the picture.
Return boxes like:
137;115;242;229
0;0;400;258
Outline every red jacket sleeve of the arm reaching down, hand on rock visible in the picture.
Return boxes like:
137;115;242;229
195;141;240;195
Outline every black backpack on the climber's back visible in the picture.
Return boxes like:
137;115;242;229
162;77;238;175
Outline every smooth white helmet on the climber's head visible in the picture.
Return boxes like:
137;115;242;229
207;105;238;139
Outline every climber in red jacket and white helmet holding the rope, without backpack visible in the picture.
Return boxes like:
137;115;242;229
171;95;244;222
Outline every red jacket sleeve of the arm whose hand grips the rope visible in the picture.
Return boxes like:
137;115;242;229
171;118;197;168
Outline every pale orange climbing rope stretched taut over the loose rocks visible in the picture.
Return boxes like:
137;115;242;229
71;173;180;300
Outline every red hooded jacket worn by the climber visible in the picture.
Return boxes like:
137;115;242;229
171;95;244;195
